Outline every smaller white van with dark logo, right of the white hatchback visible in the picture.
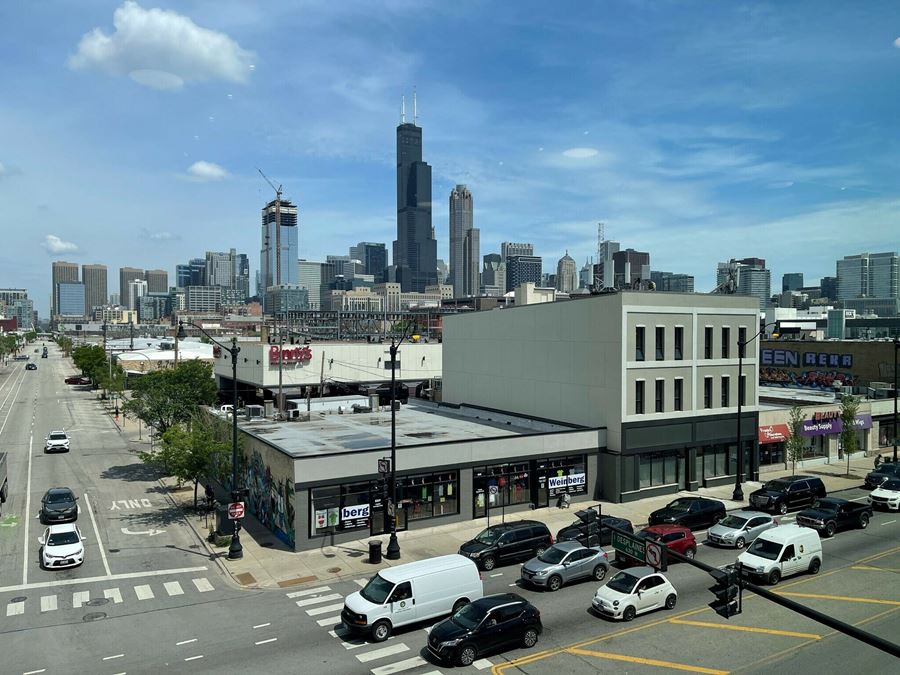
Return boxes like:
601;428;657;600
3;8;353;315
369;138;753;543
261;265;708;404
737;525;822;585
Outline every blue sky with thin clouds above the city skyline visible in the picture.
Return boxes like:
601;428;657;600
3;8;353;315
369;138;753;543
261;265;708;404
0;0;900;317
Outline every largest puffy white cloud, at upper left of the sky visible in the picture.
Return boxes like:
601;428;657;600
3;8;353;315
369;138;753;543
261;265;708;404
68;0;254;91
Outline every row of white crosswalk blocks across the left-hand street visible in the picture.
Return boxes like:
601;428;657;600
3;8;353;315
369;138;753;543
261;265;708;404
6;577;215;617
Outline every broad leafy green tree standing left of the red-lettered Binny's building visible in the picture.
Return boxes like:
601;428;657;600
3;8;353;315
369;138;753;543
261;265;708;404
123;359;216;434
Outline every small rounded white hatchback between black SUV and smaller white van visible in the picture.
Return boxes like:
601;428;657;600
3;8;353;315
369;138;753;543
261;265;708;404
591;567;678;621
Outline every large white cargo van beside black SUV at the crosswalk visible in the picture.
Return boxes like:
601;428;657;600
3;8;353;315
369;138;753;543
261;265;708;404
341;553;484;642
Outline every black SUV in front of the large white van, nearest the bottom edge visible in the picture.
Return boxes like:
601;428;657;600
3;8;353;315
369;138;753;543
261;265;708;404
428;593;544;666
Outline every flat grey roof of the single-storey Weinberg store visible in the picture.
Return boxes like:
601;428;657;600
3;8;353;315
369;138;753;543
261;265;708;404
225;399;583;459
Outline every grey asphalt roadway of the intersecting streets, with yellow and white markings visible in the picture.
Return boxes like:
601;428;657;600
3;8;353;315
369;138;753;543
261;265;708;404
0;346;900;675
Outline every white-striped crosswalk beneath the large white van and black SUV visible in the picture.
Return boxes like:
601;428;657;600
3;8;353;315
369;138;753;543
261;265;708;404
285;579;493;675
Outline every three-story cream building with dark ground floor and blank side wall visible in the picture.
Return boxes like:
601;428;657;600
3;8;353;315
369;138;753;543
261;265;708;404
443;291;760;501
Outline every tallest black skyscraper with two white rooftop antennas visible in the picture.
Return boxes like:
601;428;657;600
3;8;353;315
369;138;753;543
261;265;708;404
394;94;437;293
